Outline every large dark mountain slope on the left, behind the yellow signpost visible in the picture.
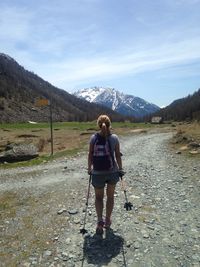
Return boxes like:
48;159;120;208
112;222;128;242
0;53;124;122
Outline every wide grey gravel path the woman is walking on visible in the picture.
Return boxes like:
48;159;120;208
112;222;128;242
0;132;200;267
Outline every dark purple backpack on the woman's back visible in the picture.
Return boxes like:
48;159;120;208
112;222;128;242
92;133;113;171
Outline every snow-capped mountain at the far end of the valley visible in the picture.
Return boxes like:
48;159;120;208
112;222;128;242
74;87;160;118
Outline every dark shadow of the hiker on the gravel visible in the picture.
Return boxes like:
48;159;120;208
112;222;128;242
82;229;126;267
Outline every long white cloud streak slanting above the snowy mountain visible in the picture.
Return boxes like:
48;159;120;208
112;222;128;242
39;35;200;87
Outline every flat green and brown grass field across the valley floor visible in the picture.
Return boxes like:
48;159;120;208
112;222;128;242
0;122;200;166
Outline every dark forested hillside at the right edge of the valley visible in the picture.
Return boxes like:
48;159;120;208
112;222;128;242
154;89;200;121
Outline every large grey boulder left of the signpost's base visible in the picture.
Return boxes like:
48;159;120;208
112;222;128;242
0;144;39;162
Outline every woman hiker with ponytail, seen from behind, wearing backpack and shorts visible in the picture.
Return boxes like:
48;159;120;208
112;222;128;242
88;115;123;235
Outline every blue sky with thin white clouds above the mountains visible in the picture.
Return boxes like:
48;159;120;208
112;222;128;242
0;0;200;106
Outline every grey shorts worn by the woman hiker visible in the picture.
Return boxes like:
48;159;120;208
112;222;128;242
92;172;119;188
